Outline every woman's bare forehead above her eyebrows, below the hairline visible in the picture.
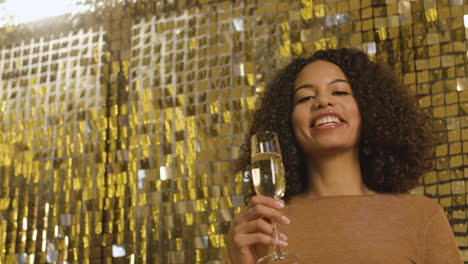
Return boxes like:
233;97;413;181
295;60;348;85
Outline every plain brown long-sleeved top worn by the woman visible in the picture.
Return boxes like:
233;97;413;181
279;194;463;264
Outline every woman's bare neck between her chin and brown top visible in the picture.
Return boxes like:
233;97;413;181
307;150;375;196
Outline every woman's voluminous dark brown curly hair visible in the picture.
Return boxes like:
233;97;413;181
237;48;433;200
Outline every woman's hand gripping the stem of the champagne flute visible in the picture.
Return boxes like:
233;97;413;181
227;195;290;264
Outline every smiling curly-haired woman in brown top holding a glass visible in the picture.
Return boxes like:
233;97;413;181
227;49;462;264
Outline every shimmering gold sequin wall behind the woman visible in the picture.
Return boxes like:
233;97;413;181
0;0;468;264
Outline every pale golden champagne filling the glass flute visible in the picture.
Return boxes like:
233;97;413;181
252;152;286;199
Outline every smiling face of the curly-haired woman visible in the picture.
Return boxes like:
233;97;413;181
292;60;361;156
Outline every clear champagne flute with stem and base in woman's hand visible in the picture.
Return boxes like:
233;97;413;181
251;131;303;264
